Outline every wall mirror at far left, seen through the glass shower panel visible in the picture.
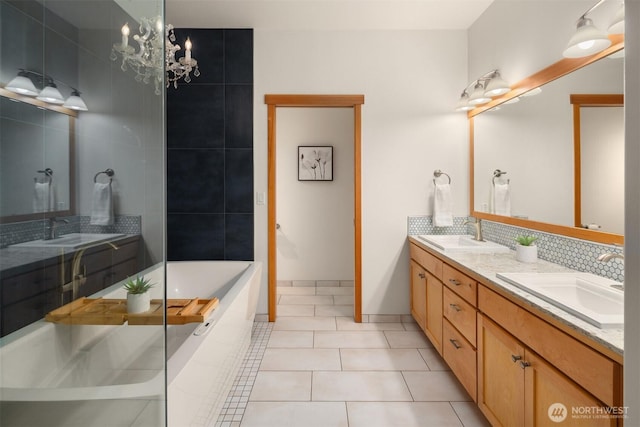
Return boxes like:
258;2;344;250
0;89;75;223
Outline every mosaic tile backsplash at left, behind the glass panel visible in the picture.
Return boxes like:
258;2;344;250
0;215;142;248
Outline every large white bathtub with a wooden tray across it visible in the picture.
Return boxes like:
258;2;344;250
0;261;262;427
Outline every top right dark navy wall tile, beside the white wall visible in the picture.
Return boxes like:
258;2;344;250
224;30;253;84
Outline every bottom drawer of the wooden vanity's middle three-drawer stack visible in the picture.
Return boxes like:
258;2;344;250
442;319;477;402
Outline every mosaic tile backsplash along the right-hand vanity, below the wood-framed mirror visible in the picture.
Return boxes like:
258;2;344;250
407;216;624;282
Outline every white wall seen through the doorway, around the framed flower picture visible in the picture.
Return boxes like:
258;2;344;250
276;108;354;280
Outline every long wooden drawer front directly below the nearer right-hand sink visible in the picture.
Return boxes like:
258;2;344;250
478;286;622;406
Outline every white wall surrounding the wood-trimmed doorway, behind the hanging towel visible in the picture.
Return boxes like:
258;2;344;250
254;30;469;314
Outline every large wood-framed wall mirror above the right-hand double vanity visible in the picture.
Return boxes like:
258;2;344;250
469;38;624;243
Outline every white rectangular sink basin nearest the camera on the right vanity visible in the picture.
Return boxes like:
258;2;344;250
497;272;624;329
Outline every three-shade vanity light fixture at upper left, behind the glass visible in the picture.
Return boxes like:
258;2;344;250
5;69;88;111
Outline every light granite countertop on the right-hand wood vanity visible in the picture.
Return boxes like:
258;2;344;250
409;236;624;356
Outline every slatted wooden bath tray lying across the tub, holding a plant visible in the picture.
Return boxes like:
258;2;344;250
45;298;220;325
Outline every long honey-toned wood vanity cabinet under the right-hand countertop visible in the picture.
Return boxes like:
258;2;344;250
410;242;623;427
